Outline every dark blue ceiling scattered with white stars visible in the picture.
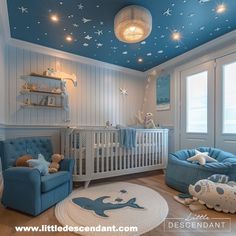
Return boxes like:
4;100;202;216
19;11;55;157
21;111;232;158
7;0;236;71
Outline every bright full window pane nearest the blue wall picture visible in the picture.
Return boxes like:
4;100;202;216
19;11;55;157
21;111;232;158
186;71;208;133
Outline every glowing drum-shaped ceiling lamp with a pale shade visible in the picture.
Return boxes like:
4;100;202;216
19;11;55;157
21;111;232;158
114;5;152;43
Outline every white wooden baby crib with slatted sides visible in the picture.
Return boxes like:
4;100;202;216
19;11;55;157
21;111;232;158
61;127;168;186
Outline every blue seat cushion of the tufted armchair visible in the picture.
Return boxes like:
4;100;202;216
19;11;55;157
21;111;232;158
41;171;71;193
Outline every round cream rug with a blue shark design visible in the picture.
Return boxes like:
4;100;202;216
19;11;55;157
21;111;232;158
55;182;168;235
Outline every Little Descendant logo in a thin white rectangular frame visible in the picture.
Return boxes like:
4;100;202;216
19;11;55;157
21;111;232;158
164;213;231;233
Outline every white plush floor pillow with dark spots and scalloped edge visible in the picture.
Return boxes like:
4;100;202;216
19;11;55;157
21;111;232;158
189;178;236;214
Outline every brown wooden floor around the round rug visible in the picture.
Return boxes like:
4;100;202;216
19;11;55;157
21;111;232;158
0;171;236;236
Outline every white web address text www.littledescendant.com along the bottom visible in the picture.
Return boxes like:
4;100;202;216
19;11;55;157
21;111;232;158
15;225;138;232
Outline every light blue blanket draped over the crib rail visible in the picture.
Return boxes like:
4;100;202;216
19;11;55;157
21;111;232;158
119;128;136;149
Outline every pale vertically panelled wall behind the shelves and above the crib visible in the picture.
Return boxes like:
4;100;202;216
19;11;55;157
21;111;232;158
6;46;145;125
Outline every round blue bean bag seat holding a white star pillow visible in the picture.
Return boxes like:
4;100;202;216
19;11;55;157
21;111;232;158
165;147;236;193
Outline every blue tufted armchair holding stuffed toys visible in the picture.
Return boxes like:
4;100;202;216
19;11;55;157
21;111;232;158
0;137;74;216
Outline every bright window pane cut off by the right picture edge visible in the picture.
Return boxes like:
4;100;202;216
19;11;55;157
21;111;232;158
223;62;236;134
